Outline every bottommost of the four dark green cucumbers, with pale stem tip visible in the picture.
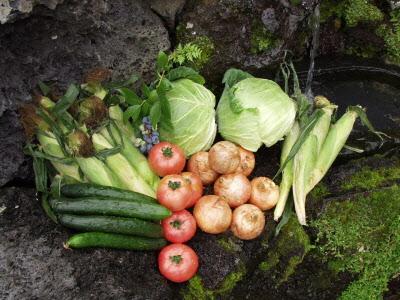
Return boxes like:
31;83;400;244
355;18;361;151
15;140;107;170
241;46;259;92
65;232;167;250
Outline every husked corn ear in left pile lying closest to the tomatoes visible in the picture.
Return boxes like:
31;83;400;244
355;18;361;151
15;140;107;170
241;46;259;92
101;124;160;190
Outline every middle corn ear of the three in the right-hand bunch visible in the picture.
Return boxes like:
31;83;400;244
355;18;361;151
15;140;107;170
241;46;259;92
293;105;336;225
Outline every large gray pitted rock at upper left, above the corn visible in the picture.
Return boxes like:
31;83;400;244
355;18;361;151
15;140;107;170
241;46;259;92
0;0;170;115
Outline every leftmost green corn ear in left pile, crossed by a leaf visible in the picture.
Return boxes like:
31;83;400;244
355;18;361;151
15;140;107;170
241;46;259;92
36;132;83;182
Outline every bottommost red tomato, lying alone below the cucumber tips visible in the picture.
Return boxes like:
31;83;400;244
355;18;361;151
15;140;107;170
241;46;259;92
158;244;199;282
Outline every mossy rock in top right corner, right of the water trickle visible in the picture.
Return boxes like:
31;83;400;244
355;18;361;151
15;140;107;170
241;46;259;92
321;0;400;64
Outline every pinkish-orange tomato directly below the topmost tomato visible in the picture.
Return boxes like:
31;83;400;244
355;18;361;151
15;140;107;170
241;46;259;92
157;175;192;211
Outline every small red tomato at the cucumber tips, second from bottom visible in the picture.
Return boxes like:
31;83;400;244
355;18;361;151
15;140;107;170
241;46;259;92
162;209;197;243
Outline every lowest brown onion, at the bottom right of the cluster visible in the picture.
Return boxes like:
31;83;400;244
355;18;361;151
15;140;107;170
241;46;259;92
231;204;265;240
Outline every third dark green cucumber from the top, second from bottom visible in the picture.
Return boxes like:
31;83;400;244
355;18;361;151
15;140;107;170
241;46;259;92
58;214;163;238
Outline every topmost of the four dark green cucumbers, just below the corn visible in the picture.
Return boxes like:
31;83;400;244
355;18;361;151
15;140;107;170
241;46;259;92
61;183;157;203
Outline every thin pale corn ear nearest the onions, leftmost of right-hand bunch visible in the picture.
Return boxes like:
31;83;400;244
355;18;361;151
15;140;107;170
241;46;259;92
274;122;300;221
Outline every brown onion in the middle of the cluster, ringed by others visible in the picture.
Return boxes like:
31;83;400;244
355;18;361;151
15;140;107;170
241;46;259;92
214;173;251;207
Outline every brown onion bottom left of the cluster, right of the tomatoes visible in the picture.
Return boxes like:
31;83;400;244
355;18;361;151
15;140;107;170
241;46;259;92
193;195;232;234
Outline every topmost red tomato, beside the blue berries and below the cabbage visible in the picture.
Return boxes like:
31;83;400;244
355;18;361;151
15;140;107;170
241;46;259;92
149;142;186;177
